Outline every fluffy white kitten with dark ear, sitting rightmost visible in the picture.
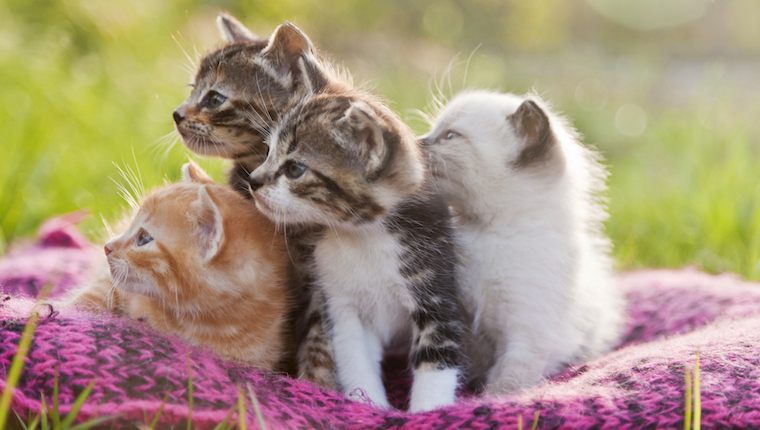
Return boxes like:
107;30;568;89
422;91;623;394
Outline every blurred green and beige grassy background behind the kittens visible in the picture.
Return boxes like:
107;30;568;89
0;0;760;279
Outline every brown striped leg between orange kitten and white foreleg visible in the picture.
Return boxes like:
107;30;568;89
298;293;340;391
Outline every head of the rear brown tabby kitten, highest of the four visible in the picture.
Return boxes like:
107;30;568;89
174;14;351;198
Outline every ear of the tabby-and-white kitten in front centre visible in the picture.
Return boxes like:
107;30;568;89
341;101;387;172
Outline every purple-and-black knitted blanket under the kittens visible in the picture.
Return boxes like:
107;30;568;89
0;219;760;429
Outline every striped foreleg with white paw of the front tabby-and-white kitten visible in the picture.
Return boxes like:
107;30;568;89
409;297;463;413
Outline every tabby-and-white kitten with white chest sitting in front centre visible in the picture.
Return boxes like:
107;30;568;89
250;91;463;412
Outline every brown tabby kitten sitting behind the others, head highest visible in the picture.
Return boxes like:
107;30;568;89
174;14;352;390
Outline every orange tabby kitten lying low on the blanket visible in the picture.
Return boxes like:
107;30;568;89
68;162;288;369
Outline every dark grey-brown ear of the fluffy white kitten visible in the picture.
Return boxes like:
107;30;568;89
507;100;556;167
